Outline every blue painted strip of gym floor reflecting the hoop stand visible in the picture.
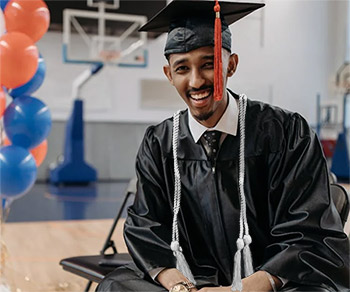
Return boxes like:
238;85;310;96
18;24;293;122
6;180;128;222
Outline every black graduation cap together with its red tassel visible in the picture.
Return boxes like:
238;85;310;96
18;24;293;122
140;0;265;100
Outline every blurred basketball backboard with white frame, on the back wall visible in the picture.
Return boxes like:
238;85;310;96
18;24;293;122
63;0;147;67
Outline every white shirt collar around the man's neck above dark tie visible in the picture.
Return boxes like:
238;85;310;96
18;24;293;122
188;93;238;143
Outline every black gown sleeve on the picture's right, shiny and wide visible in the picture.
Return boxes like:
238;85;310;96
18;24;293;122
260;114;349;291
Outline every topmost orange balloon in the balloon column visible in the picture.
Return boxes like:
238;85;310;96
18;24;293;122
4;0;50;43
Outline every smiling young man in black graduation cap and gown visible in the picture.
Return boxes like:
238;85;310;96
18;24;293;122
97;0;349;292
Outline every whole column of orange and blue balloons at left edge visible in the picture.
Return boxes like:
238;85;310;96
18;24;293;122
0;0;51;210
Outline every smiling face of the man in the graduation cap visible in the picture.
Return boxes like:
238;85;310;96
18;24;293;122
164;47;238;127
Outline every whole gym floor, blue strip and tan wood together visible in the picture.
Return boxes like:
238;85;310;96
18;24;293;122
0;181;350;292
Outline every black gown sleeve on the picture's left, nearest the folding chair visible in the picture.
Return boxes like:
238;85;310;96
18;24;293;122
124;127;176;274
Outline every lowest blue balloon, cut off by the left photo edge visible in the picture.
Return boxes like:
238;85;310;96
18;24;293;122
0;145;37;198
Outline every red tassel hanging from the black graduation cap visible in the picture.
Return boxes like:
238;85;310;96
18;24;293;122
214;0;223;101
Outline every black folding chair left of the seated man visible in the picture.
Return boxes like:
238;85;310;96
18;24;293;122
60;179;136;291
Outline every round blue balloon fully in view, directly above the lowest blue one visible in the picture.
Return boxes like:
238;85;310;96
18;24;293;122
4;95;52;149
